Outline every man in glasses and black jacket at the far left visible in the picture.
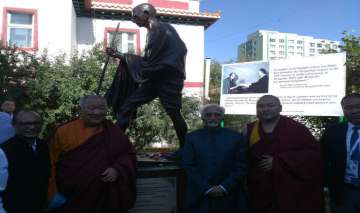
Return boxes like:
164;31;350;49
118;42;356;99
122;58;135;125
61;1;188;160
0;110;50;213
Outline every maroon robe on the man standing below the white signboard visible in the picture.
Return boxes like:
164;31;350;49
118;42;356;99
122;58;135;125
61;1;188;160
247;116;324;213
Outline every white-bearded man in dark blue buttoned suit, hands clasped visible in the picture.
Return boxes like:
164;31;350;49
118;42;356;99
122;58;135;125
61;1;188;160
182;104;247;213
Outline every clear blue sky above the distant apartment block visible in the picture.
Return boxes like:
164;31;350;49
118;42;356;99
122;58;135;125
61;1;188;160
200;0;360;62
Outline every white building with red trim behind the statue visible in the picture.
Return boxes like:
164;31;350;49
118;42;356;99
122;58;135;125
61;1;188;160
0;0;220;96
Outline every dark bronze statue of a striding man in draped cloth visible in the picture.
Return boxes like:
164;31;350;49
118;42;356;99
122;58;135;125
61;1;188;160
106;3;187;147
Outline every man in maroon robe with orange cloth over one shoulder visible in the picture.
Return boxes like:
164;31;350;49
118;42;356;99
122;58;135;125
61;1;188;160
49;95;136;213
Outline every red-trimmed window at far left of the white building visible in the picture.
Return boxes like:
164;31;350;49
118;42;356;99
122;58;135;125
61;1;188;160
2;7;38;50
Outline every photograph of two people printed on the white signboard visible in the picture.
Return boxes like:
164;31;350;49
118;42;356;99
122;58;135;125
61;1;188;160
222;62;269;94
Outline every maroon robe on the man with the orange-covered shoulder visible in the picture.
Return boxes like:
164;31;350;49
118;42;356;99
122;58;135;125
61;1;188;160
55;121;136;213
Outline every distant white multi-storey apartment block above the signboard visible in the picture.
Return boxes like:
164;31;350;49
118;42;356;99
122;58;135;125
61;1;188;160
238;30;340;61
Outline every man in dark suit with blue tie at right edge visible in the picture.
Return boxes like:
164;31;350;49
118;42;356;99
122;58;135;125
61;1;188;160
321;94;360;213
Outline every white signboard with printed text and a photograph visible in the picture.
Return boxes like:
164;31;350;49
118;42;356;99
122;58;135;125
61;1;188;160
220;53;346;116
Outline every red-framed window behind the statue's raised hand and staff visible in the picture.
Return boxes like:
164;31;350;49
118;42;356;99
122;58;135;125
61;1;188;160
104;28;140;53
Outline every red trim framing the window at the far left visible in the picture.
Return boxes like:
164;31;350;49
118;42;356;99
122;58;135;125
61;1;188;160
1;7;39;51
